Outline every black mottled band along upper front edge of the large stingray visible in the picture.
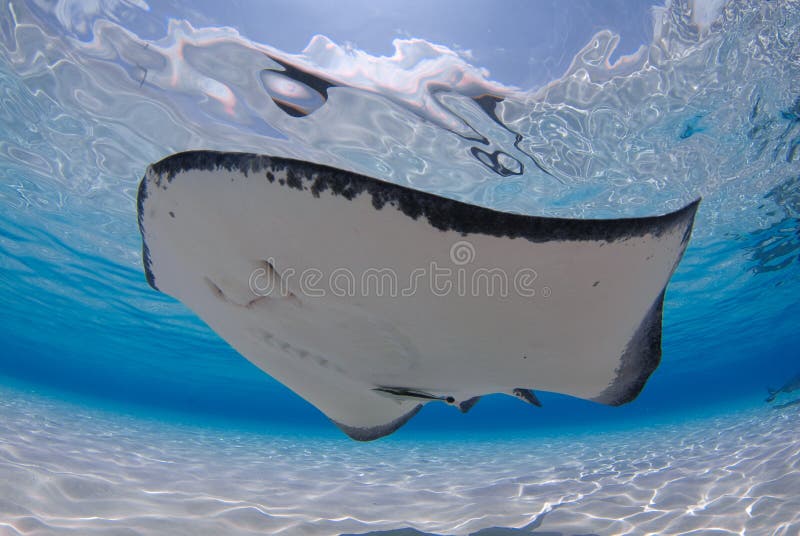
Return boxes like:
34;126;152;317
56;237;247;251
144;151;700;247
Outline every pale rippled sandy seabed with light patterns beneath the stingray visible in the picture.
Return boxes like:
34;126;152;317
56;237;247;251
0;388;800;536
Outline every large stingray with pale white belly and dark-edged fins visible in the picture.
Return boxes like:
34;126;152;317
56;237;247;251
138;151;699;441
